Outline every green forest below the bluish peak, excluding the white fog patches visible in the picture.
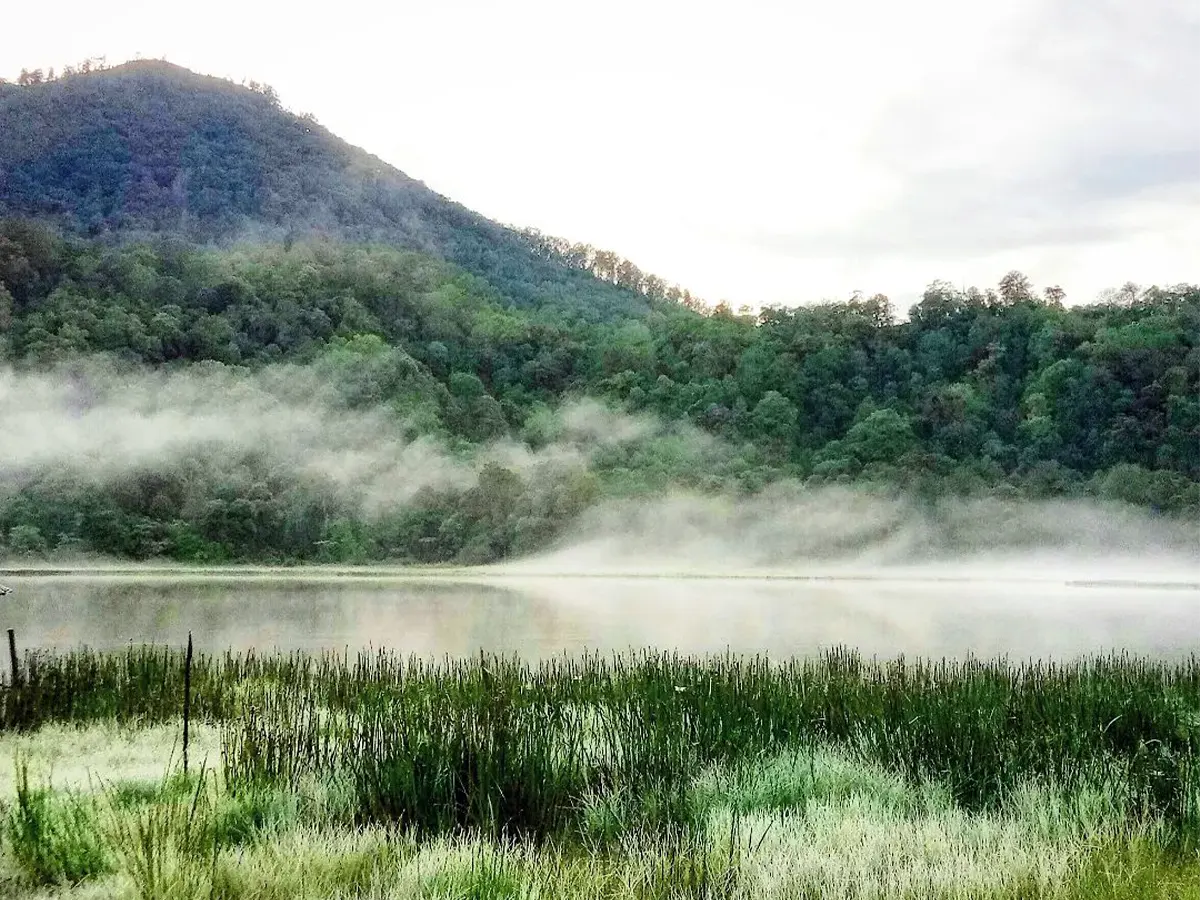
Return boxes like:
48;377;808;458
0;220;1200;562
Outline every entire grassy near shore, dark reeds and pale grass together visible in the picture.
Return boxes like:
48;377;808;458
0;648;1200;900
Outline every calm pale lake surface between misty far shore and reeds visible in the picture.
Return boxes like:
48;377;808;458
0;568;1200;659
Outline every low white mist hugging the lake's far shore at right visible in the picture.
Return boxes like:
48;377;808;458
503;484;1200;584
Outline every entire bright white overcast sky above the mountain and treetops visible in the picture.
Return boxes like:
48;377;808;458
0;0;1200;305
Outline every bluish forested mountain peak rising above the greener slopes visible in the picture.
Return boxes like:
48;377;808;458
0;61;649;322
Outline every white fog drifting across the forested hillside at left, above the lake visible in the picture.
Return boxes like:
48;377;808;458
0;361;652;518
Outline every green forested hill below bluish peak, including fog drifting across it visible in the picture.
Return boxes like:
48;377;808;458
0;214;1200;562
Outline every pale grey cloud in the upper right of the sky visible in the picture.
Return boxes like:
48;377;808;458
751;0;1200;266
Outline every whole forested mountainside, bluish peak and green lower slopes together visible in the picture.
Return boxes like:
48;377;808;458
0;62;1200;562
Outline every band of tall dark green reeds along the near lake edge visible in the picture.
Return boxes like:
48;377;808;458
7;648;1200;850
